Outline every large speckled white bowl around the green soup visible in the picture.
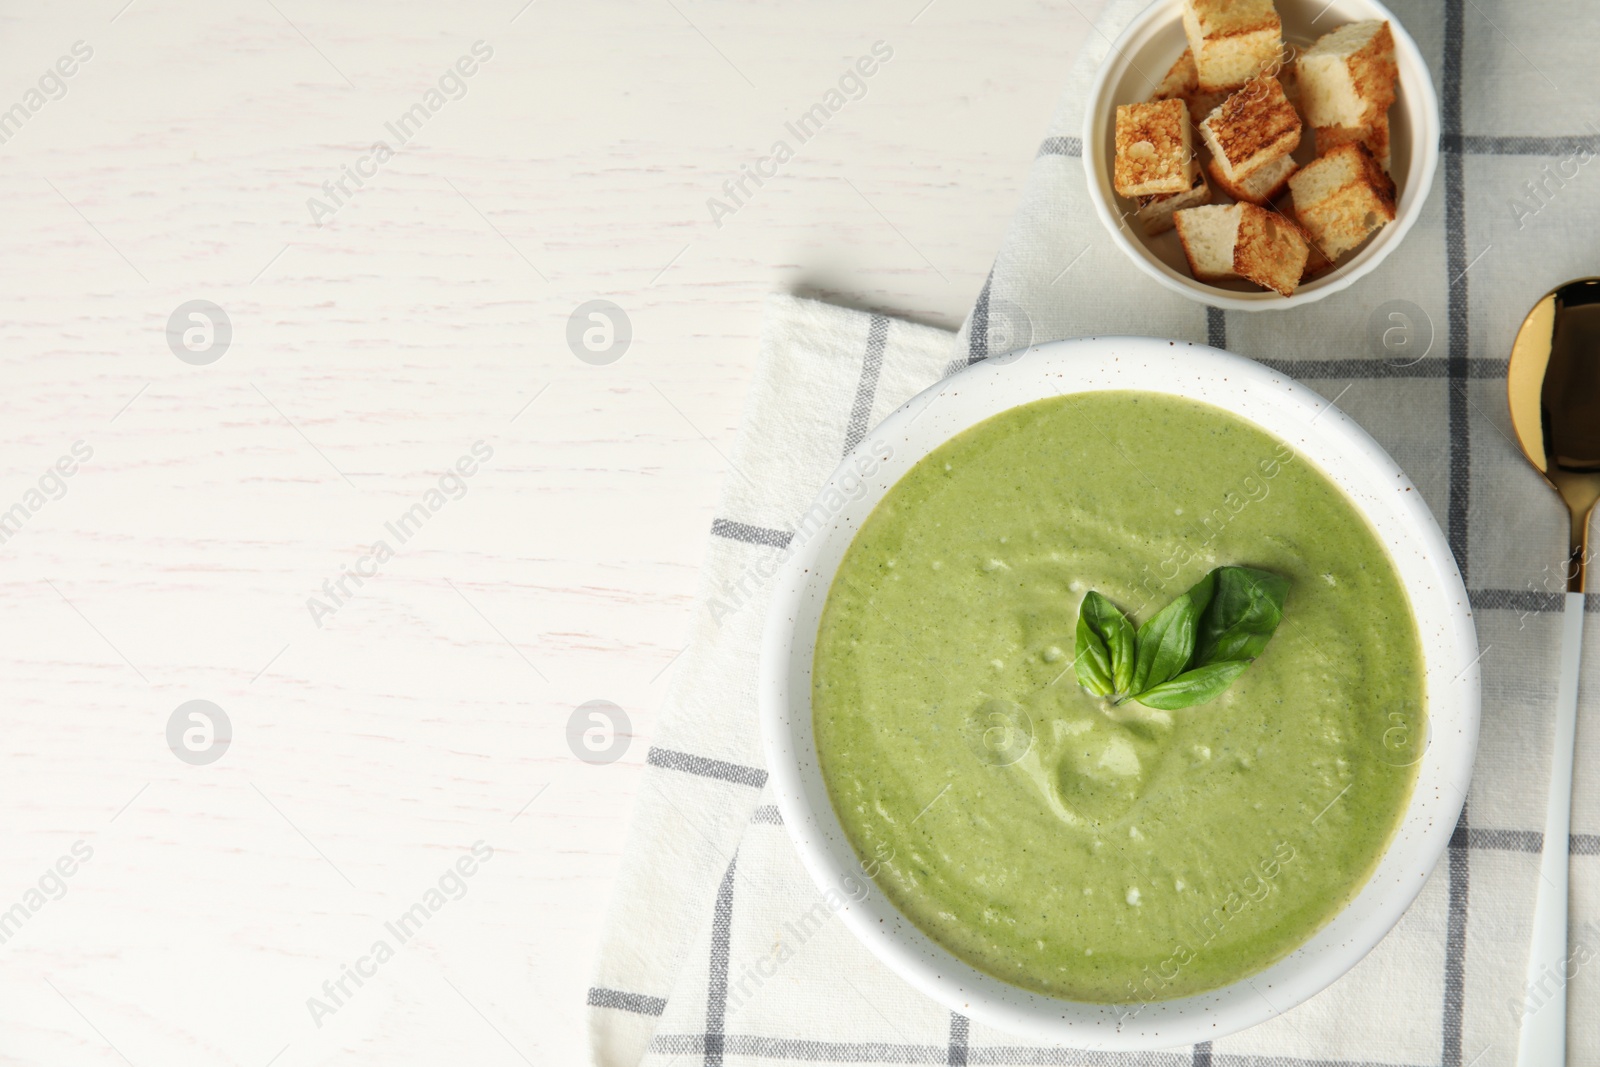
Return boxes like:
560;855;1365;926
758;338;1478;1049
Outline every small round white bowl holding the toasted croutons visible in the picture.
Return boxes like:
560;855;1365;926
1083;0;1440;312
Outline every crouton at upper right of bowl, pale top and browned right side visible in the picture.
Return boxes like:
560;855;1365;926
1296;19;1400;126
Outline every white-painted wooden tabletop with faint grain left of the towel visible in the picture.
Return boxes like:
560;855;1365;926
0;0;1098;1067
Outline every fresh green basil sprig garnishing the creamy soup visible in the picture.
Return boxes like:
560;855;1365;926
1077;566;1290;712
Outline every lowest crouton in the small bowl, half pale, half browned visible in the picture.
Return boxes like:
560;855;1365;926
1173;203;1309;296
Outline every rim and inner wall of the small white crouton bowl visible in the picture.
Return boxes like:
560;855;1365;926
1083;0;1442;312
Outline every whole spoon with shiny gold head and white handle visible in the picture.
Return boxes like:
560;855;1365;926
1506;278;1600;1067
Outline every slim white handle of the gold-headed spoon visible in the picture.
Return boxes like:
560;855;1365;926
1517;592;1584;1067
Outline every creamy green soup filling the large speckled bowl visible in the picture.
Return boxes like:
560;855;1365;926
813;392;1426;1005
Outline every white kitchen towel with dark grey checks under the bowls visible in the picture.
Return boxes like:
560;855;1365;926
589;0;1600;1067
